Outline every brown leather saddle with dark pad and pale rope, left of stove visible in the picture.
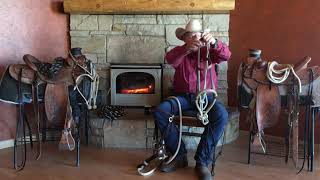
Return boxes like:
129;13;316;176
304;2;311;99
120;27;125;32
0;48;95;169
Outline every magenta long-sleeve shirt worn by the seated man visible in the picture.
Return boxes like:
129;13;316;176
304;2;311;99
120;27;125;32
165;41;231;93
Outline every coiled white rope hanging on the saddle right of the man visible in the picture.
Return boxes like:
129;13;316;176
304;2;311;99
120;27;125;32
267;61;301;93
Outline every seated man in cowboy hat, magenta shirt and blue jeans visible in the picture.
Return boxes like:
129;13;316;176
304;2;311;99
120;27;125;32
154;20;231;180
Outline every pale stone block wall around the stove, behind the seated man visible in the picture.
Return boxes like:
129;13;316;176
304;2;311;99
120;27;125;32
70;14;229;104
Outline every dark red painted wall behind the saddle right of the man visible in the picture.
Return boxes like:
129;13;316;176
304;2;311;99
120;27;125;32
228;0;320;141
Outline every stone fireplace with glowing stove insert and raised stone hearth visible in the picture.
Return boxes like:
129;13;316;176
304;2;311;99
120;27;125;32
70;6;239;148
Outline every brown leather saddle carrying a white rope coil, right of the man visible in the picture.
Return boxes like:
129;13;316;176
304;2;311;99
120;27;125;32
237;50;320;167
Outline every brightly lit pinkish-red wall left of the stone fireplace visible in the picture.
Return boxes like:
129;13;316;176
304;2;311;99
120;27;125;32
0;0;69;140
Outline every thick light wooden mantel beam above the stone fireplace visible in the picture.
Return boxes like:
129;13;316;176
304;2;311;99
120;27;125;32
63;0;235;14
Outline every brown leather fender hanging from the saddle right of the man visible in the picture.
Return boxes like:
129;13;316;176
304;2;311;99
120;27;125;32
256;85;281;132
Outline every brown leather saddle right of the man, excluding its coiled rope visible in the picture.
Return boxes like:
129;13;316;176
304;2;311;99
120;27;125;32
238;52;320;168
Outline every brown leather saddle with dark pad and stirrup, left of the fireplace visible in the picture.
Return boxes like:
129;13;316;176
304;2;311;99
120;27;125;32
0;54;91;159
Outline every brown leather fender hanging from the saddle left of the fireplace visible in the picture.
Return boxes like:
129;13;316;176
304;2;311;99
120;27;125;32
44;84;69;125
